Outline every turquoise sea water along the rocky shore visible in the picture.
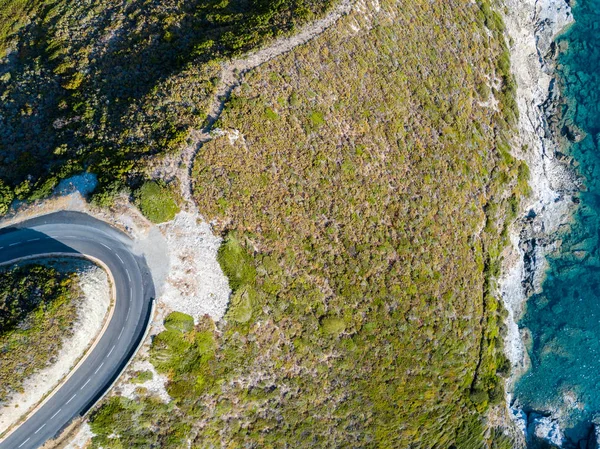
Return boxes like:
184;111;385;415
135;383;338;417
515;0;600;447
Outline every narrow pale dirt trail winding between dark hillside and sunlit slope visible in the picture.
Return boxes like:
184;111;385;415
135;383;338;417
178;0;355;205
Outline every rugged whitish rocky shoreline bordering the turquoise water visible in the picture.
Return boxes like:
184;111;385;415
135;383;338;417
499;0;584;447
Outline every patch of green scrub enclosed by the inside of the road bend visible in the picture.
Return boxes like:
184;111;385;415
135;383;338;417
0;265;78;404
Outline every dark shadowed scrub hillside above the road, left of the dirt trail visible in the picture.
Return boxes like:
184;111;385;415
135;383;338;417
0;0;338;212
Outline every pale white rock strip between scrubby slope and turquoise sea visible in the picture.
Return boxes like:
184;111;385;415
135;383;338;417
500;0;578;444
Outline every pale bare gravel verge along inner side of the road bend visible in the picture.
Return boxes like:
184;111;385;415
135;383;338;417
0;259;110;433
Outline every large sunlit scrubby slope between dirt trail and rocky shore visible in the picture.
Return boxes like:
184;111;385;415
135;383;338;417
92;0;526;449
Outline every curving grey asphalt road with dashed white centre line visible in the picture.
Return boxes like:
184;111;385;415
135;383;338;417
0;212;154;449
